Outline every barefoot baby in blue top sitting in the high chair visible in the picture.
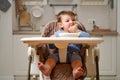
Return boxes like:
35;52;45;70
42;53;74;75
38;11;90;79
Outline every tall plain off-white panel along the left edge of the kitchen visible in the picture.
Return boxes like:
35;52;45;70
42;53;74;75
0;0;14;80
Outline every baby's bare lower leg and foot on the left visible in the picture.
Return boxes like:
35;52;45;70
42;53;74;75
38;57;56;76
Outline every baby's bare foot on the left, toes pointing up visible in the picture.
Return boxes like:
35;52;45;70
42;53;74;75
38;62;51;76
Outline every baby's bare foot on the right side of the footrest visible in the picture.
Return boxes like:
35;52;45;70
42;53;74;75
73;67;84;79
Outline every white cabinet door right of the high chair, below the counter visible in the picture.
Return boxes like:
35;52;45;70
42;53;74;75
99;36;116;75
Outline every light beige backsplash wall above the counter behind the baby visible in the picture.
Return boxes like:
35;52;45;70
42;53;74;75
13;0;116;31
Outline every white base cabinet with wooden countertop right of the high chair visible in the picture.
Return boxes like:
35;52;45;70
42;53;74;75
89;32;118;76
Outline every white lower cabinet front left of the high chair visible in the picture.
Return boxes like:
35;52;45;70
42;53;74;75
13;35;40;75
